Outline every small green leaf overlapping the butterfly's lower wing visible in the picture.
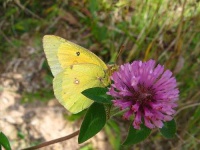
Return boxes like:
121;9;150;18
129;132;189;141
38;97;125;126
82;87;112;104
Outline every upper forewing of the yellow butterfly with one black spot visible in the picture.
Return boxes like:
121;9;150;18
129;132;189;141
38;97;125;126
43;35;107;76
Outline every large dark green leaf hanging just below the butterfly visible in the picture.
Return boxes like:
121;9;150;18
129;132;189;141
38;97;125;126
78;103;106;144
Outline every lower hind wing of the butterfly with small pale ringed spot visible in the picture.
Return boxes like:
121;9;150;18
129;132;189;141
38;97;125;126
53;64;109;113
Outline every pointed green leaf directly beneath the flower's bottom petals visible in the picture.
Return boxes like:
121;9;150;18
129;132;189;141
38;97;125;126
123;124;151;145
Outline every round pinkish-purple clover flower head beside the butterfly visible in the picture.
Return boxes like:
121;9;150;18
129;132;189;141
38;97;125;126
108;60;179;129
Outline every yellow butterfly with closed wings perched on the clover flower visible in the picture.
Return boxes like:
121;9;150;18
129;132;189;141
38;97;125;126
43;35;110;113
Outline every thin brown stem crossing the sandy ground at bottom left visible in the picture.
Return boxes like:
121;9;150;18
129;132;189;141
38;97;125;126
22;130;79;150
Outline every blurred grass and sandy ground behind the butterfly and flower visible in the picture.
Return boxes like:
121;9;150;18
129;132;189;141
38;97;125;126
0;0;200;150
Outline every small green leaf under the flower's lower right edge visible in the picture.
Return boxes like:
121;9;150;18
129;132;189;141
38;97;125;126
160;119;176;138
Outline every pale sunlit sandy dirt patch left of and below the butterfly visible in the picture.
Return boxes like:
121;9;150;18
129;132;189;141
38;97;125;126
0;56;111;150
